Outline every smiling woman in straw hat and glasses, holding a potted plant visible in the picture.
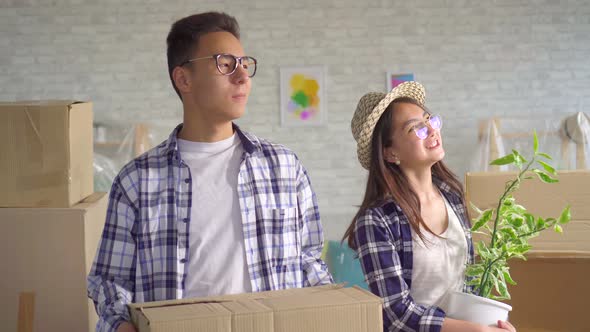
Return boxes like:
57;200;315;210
344;82;516;332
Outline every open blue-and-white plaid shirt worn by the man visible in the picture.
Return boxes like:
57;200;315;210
88;126;332;331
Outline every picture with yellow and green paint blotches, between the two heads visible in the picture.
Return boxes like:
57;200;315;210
280;66;327;127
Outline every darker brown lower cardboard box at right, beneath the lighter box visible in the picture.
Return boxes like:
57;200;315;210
506;252;590;332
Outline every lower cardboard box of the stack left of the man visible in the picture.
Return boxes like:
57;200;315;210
0;193;108;332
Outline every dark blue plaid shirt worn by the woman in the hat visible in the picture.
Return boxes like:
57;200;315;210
354;178;473;332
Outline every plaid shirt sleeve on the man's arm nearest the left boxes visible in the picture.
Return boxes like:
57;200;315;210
87;177;136;332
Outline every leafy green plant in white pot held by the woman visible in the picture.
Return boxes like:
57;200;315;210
443;133;571;326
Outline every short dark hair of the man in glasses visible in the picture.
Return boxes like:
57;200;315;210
166;12;240;99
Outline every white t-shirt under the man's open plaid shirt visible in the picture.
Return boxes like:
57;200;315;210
178;134;252;298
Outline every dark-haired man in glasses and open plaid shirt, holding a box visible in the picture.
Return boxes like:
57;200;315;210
88;12;332;331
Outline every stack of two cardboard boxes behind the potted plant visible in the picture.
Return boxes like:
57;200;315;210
465;170;590;332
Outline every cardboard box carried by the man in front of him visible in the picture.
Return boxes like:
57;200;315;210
129;285;383;332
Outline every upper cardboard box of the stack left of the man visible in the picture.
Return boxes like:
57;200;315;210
0;101;94;207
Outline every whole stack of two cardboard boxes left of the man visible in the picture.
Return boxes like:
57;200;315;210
0;101;107;331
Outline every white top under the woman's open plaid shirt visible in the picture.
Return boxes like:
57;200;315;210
410;196;467;306
